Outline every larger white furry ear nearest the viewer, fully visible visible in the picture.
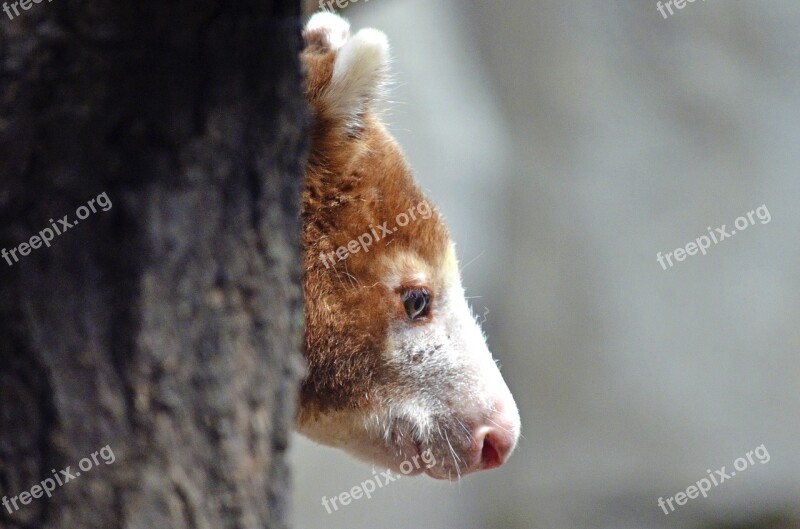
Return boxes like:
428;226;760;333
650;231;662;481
323;29;389;126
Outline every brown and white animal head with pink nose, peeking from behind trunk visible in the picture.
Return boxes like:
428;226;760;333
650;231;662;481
296;12;520;479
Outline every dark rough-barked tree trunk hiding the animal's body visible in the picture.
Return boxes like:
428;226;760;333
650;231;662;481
0;0;308;529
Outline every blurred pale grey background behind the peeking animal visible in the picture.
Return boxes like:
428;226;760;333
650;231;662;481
292;0;800;529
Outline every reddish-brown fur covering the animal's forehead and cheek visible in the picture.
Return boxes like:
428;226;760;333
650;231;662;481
299;32;449;422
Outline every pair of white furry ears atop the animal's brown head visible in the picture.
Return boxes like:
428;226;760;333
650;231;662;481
303;12;389;128
